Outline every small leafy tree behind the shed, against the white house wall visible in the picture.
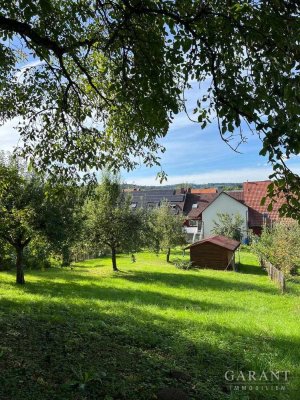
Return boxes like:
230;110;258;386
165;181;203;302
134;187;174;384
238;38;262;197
213;213;245;241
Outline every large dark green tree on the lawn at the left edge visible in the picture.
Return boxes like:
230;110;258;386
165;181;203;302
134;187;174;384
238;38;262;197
0;152;83;283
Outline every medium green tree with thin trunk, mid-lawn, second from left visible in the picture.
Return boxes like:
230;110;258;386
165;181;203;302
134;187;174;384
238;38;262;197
85;174;144;271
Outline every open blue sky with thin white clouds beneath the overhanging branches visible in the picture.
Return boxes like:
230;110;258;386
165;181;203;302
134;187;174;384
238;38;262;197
0;76;300;185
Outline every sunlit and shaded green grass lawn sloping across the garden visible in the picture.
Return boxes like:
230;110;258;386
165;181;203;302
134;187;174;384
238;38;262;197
0;252;300;400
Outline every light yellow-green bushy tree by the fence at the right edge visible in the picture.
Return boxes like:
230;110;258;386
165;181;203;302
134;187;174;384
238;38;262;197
252;222;300;277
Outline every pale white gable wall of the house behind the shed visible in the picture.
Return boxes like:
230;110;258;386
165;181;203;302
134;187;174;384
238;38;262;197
202;193;248;238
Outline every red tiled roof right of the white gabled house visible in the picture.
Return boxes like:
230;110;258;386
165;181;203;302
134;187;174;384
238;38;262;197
243;181;285;228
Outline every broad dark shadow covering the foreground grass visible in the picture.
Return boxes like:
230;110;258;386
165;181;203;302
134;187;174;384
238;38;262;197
0;284;297;400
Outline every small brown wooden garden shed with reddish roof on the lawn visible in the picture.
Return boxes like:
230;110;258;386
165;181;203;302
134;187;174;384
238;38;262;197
186;236;240;270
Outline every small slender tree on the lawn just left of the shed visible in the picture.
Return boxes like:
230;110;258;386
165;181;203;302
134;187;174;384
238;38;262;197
150;201;186;262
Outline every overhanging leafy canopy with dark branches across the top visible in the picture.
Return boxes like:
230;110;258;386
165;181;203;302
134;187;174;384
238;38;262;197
0;0;300;216
